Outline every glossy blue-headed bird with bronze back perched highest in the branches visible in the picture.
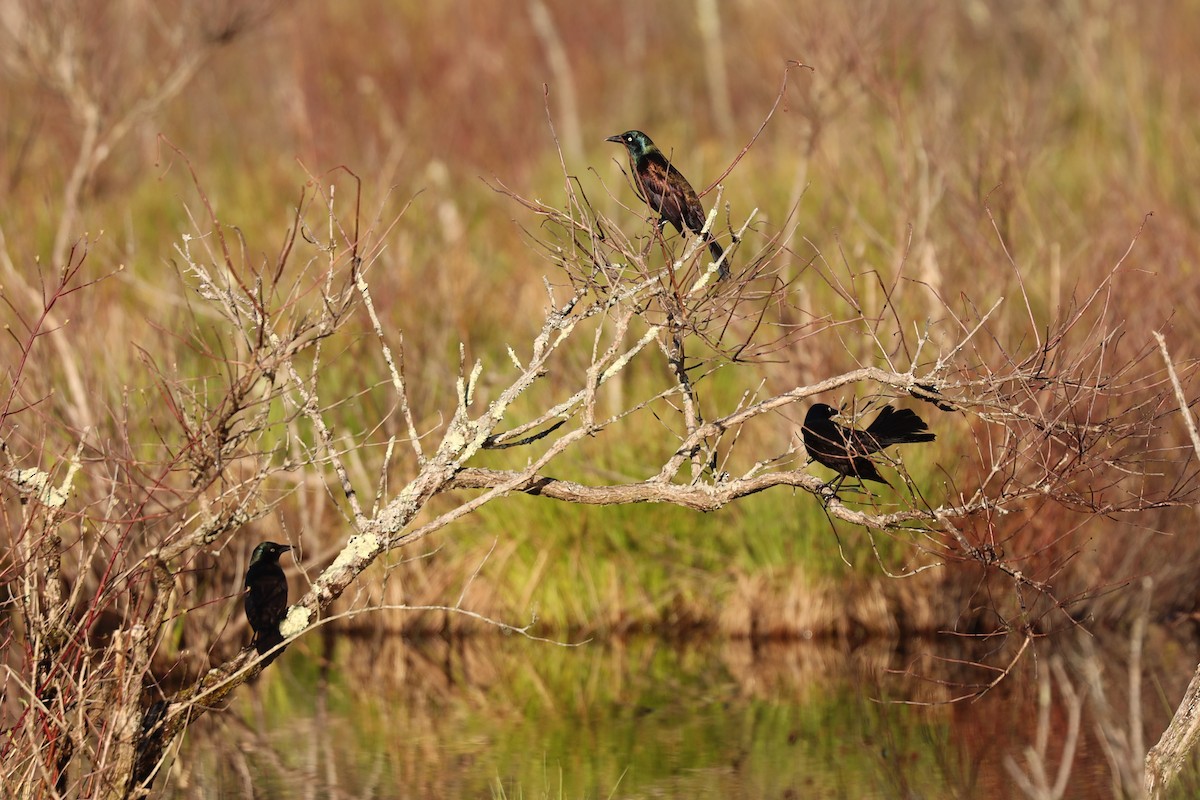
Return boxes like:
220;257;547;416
605;131;730;281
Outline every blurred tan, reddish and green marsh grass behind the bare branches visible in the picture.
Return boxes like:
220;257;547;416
0;10;1200;796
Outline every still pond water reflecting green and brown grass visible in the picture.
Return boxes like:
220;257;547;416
166;636;1200;800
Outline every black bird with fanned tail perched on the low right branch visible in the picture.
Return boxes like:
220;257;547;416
800;403;937;494
